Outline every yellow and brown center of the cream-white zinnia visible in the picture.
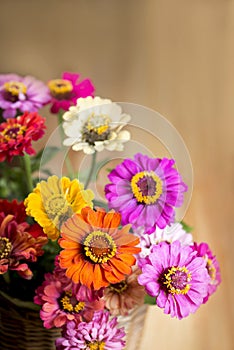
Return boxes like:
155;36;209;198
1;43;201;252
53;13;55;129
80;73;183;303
82;113;111;145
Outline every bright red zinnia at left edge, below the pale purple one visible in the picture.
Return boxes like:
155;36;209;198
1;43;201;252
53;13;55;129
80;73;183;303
0;112;46;162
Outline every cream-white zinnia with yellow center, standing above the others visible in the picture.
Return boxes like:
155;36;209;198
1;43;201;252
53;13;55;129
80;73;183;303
63;96;131;154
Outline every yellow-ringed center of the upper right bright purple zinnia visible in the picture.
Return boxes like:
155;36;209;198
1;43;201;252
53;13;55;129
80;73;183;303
131;171;163;204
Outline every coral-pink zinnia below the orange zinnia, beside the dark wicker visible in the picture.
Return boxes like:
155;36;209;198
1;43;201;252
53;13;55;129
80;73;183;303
34;269;104;329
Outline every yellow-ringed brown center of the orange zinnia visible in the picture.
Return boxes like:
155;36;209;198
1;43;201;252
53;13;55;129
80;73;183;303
83;231;117;264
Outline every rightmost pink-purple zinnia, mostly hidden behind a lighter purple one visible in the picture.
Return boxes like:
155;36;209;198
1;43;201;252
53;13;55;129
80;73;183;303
194;243;221;303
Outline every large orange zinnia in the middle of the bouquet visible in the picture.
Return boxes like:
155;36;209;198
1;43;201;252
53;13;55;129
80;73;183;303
59;207;140;290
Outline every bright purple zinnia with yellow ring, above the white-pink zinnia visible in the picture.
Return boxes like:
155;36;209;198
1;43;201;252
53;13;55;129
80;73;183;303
105;153;187;233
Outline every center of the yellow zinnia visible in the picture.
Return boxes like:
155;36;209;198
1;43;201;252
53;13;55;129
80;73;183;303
43;194;73;228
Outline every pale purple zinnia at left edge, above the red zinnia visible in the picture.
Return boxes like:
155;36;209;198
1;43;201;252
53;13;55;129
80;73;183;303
0;74;51;119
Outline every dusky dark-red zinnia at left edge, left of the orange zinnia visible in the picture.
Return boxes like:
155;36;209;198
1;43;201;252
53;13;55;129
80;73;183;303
0;212;47;279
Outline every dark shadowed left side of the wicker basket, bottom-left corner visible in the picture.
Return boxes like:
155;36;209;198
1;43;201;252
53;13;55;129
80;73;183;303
0;293;60;350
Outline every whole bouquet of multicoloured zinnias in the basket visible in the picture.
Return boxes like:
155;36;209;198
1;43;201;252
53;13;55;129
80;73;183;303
0;72;221;350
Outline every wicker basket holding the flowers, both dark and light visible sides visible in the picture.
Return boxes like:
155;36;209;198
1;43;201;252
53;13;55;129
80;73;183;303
0;292;148;350
